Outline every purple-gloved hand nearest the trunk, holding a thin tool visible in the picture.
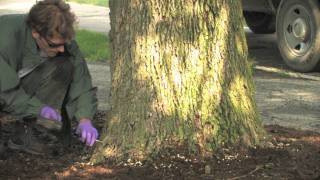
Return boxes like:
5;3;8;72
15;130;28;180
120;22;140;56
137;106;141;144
76;119;99;146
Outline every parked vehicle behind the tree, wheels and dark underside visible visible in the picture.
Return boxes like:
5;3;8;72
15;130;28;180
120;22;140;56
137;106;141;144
242;0;320;72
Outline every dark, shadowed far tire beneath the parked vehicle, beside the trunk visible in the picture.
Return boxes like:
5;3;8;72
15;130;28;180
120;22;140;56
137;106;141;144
243;11;276;34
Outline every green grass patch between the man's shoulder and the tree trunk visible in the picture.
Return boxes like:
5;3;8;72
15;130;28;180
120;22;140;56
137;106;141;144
76;30;111;62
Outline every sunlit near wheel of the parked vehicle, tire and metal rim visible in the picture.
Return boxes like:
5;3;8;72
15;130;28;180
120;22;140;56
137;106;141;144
276;0;320;72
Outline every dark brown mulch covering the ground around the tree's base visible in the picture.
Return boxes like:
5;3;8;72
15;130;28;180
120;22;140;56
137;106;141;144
0;112;320;180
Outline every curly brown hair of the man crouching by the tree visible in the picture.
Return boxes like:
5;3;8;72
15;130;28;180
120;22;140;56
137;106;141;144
26;0;75;40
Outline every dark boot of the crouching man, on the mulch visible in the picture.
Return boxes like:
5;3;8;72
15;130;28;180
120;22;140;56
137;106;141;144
8;119;45;155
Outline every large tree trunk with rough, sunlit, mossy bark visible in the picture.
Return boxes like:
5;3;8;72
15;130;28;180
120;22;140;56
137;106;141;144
94;0;264;161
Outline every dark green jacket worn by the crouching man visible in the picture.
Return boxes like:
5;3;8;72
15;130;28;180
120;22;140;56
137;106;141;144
0;15;97;120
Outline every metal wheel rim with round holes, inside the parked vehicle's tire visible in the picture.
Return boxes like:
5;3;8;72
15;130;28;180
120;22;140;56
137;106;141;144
283;5;314;56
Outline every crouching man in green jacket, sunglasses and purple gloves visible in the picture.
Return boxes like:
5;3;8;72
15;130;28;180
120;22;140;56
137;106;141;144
0;0;98;154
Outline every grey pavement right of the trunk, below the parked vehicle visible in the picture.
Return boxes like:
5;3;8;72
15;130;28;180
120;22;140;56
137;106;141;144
247;31;320;132
